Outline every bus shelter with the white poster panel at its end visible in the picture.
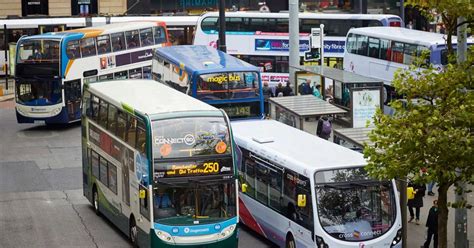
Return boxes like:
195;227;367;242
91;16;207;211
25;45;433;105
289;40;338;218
293;65;384;127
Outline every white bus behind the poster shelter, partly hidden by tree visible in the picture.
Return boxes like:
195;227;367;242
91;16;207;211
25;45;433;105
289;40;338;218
344;27;474;104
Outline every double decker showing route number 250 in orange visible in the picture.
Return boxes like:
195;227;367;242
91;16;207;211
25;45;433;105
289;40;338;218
82;79;239;247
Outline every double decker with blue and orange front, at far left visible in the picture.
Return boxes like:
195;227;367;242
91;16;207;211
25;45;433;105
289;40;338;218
15;22;169;124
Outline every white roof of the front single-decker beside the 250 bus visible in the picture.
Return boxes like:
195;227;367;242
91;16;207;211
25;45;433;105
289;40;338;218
232;120;367;176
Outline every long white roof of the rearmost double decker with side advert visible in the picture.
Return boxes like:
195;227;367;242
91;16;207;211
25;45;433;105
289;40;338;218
201;11;400;20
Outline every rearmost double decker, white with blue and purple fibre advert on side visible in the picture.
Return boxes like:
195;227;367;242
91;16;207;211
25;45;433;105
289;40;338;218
193;11;404;87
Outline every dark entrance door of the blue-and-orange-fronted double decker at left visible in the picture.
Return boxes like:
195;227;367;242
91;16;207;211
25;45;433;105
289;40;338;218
64;79;81;120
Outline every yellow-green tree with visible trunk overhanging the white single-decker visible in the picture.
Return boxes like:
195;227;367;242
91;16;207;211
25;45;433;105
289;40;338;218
364;50;474;248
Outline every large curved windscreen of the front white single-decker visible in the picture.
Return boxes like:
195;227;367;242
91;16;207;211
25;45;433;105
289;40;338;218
315;168;396;241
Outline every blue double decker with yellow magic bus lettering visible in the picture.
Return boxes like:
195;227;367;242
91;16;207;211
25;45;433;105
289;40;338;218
152;46;264;119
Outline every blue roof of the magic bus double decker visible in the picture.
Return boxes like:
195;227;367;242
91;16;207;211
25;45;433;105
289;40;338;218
155;45;259;74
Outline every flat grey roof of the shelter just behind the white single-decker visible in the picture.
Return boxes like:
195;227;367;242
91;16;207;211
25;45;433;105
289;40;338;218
268;95;347;118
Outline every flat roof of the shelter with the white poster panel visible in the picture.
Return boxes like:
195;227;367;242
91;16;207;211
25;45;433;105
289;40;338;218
292;65;383;85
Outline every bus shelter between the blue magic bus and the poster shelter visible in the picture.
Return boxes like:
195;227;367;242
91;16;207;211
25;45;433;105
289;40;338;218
268;95;347;134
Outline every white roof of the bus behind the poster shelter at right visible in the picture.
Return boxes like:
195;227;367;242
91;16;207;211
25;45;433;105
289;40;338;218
348;27;456;47
